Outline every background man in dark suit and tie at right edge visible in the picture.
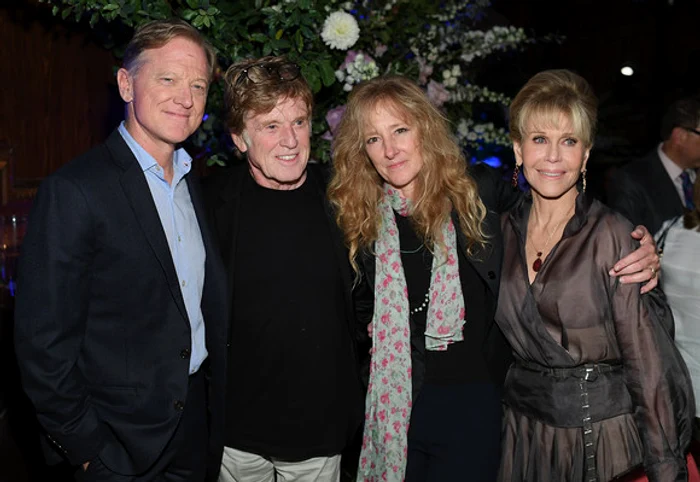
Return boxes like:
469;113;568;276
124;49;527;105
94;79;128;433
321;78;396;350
607;97;700;233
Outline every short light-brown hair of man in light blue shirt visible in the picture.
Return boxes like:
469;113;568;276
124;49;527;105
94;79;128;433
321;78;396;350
122;18;216;80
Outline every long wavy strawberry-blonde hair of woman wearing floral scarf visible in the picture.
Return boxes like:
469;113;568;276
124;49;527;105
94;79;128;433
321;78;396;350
328;76;486;274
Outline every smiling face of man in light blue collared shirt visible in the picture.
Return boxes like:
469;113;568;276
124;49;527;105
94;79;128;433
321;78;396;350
117;37;209;159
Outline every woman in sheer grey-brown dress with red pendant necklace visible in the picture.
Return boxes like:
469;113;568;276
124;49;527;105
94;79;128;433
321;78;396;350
496;70;697;482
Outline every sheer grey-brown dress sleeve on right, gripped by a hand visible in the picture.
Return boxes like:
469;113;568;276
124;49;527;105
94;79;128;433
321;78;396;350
611;223;695;482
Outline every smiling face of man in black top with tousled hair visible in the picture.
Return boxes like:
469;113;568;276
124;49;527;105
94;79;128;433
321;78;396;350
231;99;311;190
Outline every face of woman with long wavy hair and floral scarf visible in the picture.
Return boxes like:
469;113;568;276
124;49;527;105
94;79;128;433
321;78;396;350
362;103;423;199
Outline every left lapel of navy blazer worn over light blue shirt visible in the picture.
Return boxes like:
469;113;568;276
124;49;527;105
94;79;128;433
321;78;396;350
105;131;189;324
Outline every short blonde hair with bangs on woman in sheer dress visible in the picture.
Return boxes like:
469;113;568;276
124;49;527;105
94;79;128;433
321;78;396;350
509;69;598;149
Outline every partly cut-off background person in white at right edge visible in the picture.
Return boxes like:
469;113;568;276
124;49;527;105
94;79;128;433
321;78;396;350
657;174;700;441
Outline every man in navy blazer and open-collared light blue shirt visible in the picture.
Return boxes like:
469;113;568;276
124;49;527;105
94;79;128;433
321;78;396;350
15;20;226;482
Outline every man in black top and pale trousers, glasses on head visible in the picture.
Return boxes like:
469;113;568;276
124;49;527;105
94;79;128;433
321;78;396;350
207;57;362;482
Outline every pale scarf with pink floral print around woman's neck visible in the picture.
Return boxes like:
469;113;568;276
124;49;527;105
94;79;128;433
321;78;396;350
357;184;465;482
